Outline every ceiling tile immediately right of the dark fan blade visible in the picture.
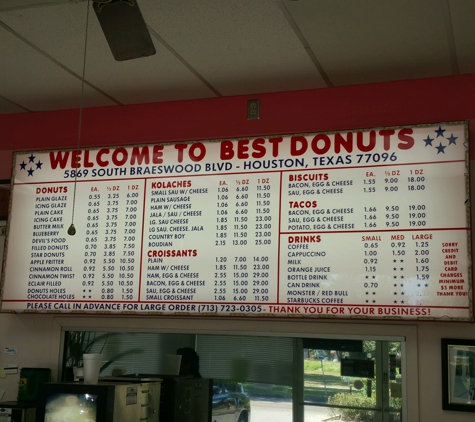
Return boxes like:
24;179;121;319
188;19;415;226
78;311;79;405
140;0;326;95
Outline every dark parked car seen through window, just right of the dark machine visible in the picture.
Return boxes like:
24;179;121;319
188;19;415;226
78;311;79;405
211;380;251;422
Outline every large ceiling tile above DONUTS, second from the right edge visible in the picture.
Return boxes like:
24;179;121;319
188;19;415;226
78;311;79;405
285;0;451;85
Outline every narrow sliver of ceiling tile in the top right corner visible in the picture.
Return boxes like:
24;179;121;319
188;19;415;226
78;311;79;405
449;0;475;73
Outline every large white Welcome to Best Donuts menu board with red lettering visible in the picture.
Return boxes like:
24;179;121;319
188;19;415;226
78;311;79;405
2;123;472;321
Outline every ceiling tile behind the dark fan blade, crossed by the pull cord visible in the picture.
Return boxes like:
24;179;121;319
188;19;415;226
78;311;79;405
0;2;215;104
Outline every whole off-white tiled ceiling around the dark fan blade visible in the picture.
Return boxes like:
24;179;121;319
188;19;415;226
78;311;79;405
0;0;475;114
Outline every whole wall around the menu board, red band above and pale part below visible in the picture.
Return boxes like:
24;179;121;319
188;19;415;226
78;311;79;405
0;75;475;422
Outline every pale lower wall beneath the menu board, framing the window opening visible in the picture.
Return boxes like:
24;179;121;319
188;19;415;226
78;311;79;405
0;314;475;422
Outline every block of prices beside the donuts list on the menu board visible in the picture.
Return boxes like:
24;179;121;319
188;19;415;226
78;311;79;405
77;181;143;301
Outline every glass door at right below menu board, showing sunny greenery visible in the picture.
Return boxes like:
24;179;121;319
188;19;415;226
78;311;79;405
300;339;405;422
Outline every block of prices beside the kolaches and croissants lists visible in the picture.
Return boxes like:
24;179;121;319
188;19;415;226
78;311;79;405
213;173;280;303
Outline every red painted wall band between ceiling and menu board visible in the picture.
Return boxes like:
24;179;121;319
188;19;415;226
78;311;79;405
0;75;475;179
